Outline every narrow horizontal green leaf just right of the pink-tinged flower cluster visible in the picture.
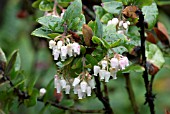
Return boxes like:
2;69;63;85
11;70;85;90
122;64;145;73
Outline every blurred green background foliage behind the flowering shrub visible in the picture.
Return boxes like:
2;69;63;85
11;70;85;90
0;0;170;114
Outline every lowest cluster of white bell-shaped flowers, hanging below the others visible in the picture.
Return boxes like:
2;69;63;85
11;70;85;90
54;74;95;99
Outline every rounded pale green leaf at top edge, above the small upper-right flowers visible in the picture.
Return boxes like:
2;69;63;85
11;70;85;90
103;1;123;14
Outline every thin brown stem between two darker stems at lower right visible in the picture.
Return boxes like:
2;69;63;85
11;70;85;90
124;73;140;114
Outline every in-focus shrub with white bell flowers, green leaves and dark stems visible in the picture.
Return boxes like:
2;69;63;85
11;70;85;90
2;0;169;114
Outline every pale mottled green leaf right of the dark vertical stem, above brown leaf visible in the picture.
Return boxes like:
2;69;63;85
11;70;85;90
146;42;165;68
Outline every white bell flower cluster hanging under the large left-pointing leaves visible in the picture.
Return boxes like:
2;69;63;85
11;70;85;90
49;40;80;61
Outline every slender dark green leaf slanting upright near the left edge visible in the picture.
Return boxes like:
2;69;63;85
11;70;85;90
4;50;18;76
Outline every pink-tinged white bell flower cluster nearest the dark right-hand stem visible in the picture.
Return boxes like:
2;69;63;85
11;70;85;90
93;55;129;82
